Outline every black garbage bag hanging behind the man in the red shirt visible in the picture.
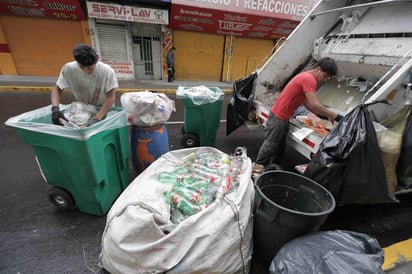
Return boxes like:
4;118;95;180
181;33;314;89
226;73;257;136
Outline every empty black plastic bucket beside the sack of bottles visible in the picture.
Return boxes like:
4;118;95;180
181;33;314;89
253;170;335;267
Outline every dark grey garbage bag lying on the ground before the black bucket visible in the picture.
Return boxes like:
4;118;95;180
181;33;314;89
269;230;385;274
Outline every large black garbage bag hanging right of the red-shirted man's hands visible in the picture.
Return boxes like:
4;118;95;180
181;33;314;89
303;101;398;205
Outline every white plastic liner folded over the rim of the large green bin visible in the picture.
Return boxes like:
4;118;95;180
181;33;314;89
5;105;127;140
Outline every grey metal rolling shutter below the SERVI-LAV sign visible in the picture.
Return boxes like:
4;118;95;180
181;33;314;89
96;23;129;62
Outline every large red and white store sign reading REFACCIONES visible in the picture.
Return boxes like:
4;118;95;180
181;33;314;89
170;0;314;39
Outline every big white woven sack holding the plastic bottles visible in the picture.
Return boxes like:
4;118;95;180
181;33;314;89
99;147;254;274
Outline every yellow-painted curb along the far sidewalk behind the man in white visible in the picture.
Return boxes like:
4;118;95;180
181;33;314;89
0;86;233;95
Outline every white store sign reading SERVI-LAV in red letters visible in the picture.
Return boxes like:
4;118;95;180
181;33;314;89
87;1;169;25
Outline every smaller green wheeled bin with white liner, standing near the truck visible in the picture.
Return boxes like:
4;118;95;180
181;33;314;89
176;86;224;148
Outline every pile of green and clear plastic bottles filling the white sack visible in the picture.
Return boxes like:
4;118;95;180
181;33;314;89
157;149;244;223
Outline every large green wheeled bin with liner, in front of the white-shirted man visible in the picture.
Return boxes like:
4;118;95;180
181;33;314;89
5;105;130;216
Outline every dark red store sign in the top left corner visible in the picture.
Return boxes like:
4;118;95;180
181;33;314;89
0;0;86;20
